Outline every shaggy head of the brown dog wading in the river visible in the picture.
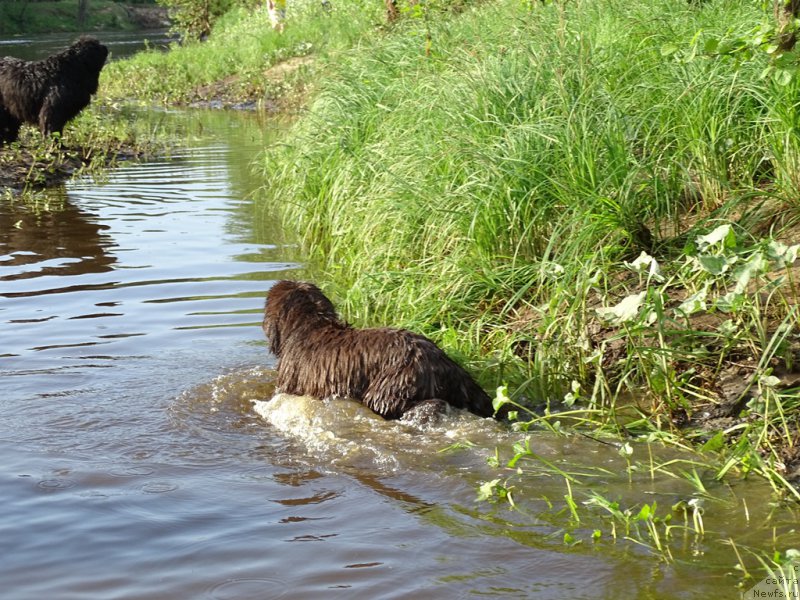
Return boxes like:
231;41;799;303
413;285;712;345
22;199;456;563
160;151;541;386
262;281;343;357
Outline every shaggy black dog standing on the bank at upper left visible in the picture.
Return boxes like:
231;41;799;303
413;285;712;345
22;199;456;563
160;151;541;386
0;37;108;144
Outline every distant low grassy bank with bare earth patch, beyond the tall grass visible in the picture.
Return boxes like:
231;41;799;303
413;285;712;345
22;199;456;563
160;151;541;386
101;2;378;110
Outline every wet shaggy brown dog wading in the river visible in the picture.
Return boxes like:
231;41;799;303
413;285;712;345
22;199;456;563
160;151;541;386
263;281;494;419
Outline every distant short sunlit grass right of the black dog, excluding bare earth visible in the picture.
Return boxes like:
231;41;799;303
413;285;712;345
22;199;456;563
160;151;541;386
100;0;376;104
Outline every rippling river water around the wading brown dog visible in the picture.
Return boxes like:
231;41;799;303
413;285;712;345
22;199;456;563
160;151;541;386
0;99;797;600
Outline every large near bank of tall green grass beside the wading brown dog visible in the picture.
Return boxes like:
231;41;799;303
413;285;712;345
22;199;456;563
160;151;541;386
256;0;800;496
